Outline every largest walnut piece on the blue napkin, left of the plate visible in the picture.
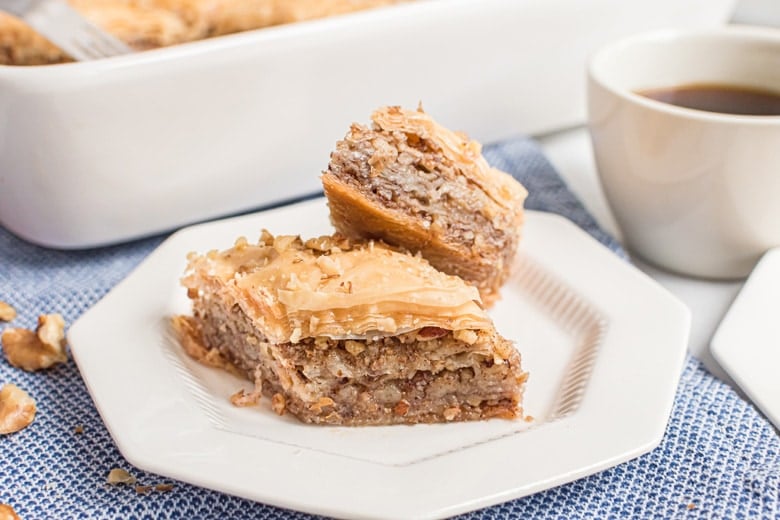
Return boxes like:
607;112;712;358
2;314;68;372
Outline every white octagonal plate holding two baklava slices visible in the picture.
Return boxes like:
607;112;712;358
68;199;690;518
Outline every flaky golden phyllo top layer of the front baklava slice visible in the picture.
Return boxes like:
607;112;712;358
183;231;493;343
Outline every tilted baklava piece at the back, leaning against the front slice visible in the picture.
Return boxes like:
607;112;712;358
322;107;527;305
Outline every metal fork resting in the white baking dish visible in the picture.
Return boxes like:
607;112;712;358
0;0;132;61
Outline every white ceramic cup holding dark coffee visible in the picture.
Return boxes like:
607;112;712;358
588;26;780;278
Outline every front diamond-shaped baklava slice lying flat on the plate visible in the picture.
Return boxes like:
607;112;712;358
173;232;527;426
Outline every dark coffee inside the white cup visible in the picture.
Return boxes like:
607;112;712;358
637;84;780;116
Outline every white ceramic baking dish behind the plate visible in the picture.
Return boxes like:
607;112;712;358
0;0;734;248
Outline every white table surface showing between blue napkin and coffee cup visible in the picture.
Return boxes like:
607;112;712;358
539;128;744;395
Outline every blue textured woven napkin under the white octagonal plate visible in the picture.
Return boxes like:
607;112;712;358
0;139;780;519
